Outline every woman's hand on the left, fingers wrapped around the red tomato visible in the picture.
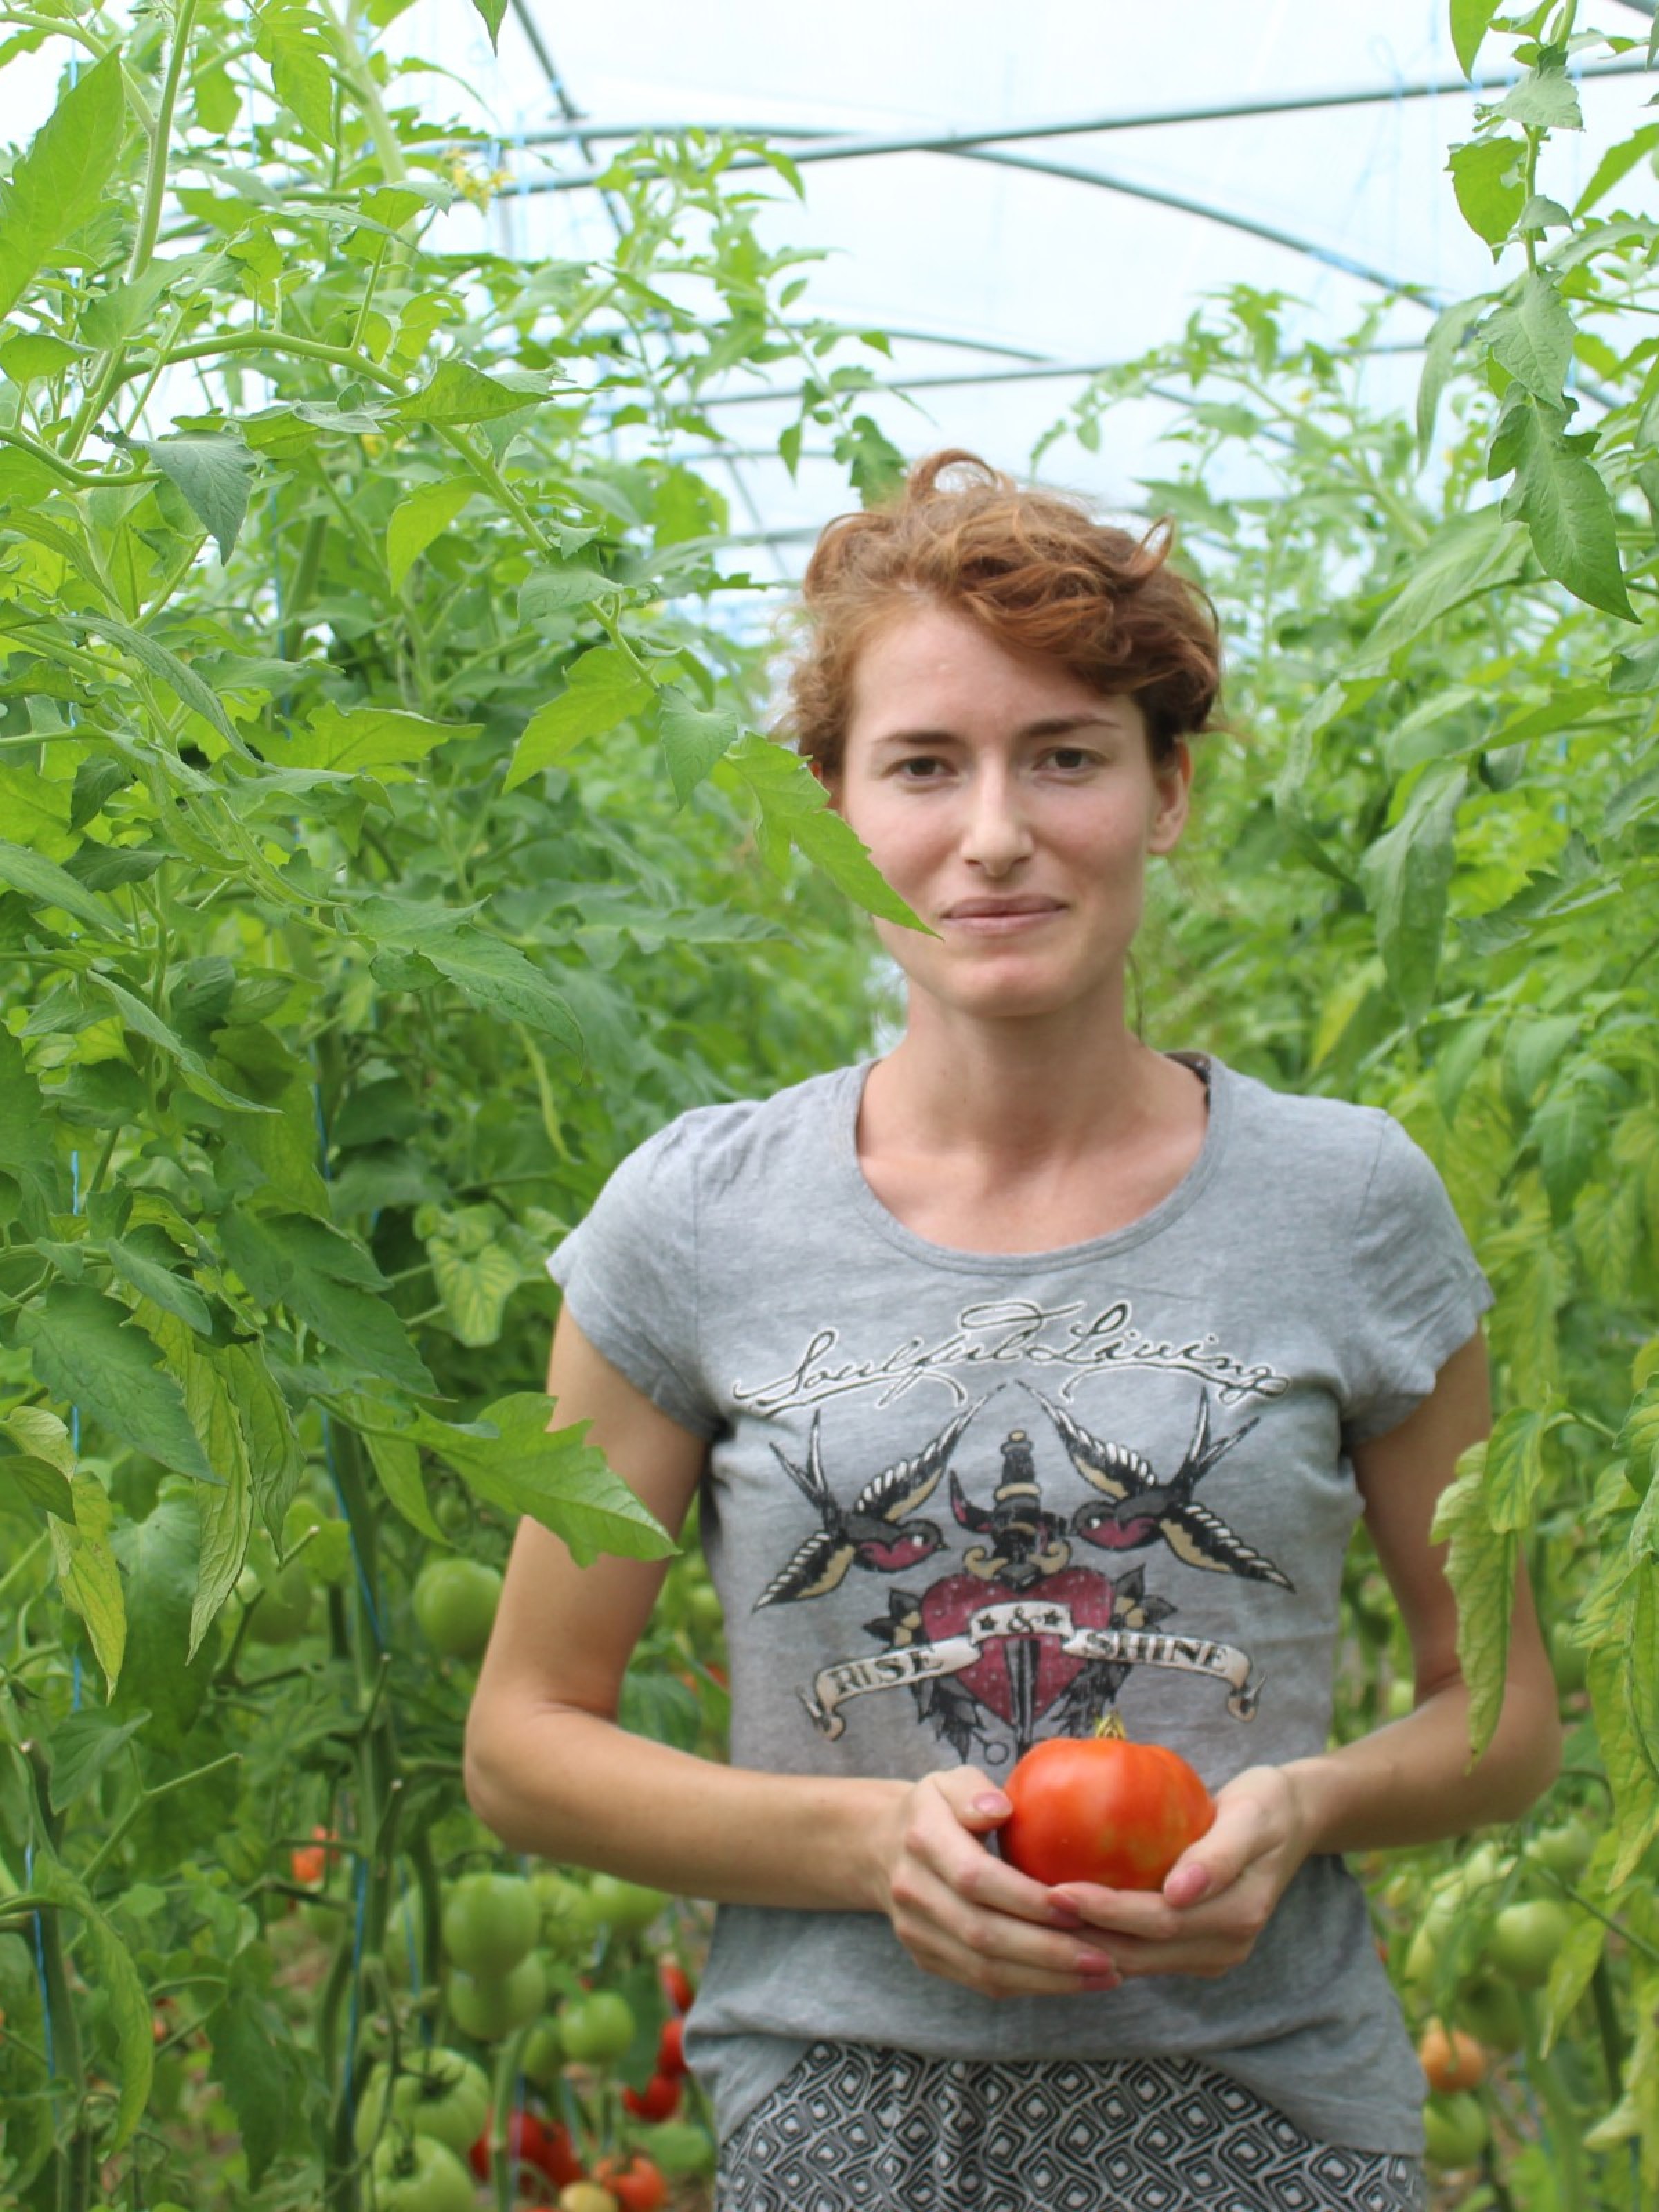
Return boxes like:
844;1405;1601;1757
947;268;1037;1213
881;1768;1119;1998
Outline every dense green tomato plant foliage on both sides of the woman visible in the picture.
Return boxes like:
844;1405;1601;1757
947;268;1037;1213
0;0;1659;2212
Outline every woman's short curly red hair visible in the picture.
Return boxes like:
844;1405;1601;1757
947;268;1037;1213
783;449;1221;776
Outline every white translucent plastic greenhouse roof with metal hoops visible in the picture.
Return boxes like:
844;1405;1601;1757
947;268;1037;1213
4;0;1659;577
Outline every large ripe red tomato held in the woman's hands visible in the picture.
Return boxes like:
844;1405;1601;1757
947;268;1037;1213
1000;1734;1215;1889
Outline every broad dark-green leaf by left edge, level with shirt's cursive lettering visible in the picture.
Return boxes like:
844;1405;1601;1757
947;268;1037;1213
15;1283;214;1482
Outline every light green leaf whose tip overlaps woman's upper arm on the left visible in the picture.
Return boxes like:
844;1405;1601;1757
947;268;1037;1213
411;1391;677;1566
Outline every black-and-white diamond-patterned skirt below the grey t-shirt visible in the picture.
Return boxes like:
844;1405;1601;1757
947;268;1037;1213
715;2042;1427;2212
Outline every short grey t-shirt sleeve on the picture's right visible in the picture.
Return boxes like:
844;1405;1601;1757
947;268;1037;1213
1342;1115;1493;1449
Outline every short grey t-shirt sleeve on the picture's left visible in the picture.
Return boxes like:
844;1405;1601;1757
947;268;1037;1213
546;1121;719;1436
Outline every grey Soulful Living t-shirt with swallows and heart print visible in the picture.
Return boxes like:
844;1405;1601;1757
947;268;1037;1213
549;1060;1491;2153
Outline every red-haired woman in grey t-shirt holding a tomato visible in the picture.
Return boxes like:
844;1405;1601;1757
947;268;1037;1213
467;453;1557;2212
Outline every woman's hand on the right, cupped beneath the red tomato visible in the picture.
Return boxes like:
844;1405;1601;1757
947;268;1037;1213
1049;1768;1309;1978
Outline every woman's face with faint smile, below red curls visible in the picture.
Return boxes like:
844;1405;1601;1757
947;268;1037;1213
830;601;1192;1022
